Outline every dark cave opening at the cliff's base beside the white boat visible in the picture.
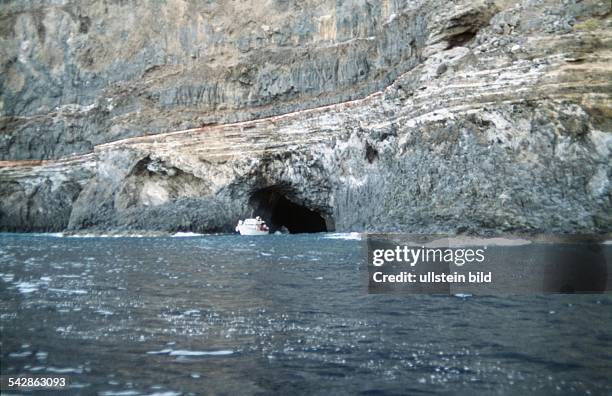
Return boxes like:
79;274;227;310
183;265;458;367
250;186;327;234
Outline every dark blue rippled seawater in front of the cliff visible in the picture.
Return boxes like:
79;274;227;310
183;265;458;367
0;234;612;396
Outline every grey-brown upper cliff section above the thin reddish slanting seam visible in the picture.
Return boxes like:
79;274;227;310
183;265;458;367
0;0;436;159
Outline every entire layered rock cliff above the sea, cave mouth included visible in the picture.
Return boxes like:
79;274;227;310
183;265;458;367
0;0;612;233
